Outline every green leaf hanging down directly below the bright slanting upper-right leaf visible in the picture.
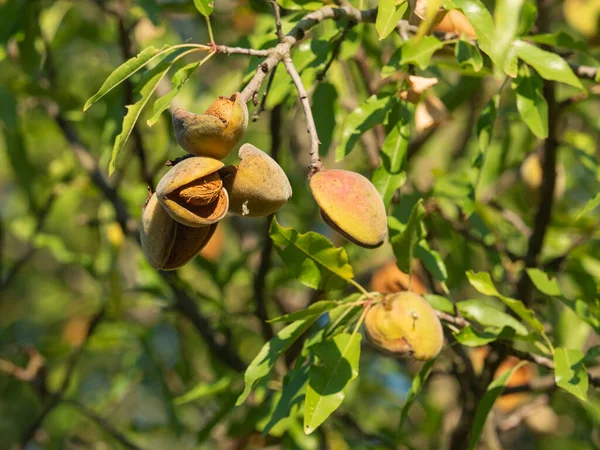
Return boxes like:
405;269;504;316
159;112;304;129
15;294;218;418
513;66;548;139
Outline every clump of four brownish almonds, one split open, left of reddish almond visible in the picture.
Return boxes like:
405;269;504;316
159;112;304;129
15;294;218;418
141;94;292;270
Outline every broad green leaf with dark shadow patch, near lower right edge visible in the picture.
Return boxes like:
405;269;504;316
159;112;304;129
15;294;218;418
554;347;589;401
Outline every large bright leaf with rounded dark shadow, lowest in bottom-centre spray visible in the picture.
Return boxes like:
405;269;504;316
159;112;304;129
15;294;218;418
304;333;362;434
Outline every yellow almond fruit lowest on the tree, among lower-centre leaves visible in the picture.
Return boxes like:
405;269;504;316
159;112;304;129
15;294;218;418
365;292;444;360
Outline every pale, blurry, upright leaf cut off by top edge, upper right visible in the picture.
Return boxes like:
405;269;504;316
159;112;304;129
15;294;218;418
494;0;524;70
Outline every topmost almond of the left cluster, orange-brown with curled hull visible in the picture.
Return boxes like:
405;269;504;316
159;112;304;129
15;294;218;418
173;92;248;159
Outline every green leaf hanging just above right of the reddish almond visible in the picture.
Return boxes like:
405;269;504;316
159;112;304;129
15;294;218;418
371;100;412;207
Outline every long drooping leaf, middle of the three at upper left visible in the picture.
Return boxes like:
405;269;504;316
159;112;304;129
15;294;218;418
108;56;173;176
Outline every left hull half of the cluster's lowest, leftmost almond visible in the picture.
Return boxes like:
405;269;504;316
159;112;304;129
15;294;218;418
140;194;176;270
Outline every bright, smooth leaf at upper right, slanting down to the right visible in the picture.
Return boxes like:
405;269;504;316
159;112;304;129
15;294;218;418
513;40;585;90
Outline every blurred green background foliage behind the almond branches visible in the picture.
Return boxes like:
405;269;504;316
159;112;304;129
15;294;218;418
0;0;600;450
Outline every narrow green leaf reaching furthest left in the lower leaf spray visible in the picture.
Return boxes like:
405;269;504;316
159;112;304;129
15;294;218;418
236;317;317;406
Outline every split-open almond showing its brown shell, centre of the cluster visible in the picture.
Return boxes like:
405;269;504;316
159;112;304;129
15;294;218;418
156;157;229;227
